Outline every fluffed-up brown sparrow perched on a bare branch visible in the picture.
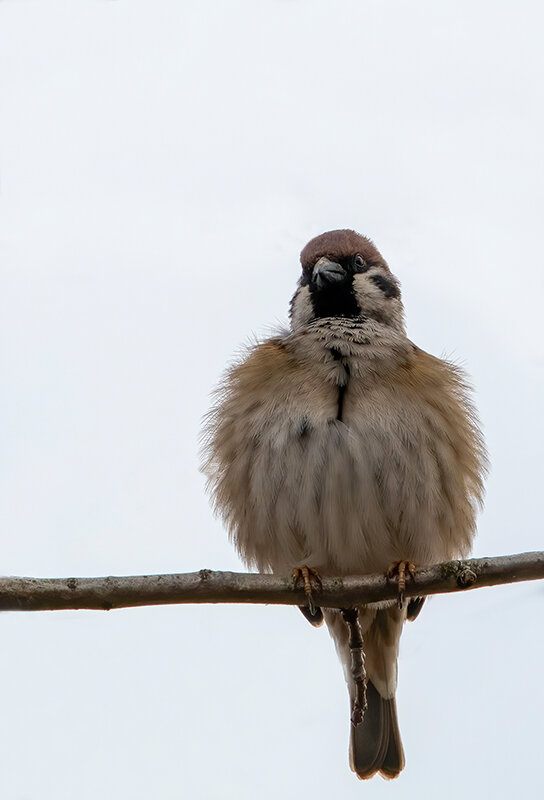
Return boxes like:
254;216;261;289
203;229;488;779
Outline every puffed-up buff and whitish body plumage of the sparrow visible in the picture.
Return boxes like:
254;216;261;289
204;330;486;574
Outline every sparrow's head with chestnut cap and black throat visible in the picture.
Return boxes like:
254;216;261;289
290;230;404;332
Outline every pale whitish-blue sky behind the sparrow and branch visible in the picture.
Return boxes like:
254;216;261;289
0;0;544;800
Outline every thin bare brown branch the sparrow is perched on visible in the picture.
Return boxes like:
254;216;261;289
0;552;544;611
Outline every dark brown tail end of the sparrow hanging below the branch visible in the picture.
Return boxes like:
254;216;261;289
350;681;404;780
